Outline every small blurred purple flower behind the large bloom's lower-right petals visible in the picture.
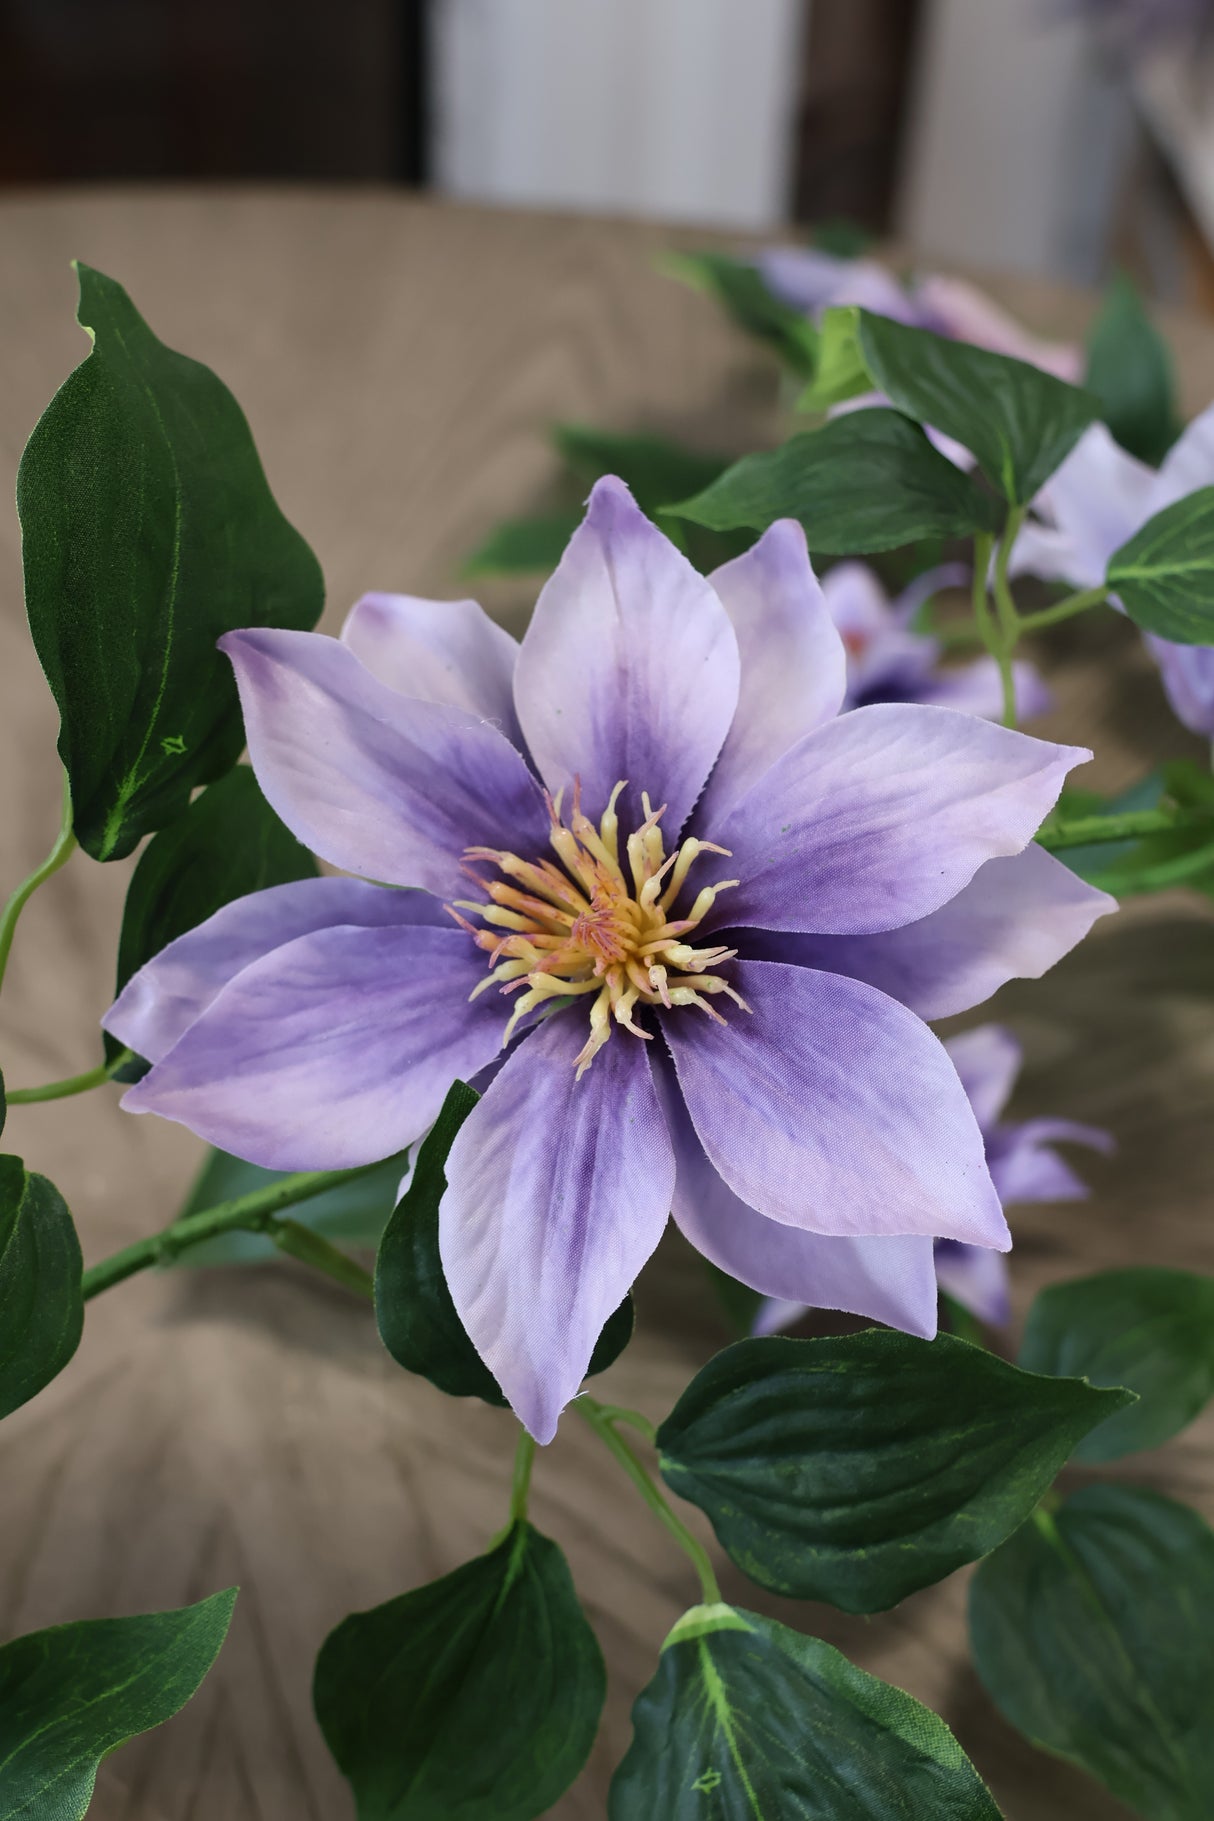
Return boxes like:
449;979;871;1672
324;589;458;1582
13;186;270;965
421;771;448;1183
754;1023;1114;1335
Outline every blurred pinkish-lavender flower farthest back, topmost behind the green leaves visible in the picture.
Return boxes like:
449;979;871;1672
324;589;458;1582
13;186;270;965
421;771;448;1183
757;246;1083;384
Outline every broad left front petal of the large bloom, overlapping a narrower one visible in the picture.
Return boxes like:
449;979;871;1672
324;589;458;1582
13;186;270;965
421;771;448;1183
122;925;508;1169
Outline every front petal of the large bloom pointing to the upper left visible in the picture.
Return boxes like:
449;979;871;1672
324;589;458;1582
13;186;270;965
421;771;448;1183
218;626;548;898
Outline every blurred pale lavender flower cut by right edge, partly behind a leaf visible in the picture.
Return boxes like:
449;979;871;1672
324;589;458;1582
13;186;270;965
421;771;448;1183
1012;404;1214;739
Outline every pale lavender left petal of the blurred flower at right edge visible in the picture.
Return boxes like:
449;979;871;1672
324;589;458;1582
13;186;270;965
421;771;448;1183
1010;424;1156;588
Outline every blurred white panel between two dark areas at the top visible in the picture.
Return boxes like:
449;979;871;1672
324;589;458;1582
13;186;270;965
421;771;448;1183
431;0;811;228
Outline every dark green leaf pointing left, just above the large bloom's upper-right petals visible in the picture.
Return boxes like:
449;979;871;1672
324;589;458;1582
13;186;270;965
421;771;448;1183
668;408;997;555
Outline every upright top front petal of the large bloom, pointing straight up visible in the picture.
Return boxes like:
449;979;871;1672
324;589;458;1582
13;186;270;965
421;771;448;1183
515;477;739;847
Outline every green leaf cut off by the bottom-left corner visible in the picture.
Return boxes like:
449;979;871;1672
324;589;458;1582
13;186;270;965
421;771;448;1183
0;1588;237;1821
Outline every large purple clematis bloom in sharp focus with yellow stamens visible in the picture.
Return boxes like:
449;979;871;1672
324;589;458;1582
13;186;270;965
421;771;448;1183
106;479;1114;1440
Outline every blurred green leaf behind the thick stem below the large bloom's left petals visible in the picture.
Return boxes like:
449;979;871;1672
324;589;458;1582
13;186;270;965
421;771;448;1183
164;1151;408;1271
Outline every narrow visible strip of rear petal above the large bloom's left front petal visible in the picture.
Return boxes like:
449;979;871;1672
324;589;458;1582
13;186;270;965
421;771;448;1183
102;880;442;1062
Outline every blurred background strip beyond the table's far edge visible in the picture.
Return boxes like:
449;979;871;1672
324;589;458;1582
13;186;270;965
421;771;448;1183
0;0;1214;308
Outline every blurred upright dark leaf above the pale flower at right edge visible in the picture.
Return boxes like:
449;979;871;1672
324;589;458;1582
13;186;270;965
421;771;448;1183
1083;273;1181;468
